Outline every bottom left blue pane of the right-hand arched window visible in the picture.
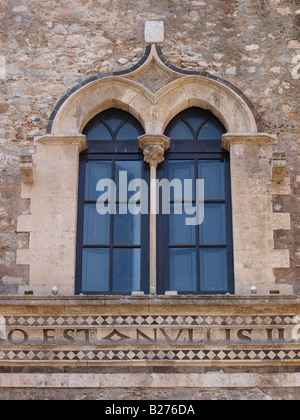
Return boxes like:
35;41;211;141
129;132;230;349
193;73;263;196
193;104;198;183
169;248;197;291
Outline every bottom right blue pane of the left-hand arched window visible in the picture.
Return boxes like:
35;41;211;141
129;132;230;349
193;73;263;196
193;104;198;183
113;249;141;292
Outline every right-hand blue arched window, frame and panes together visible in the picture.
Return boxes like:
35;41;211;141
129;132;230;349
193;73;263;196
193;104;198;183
158;108;234;294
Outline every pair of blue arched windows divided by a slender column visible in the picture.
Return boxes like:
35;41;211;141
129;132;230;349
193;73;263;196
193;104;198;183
76;108;234;295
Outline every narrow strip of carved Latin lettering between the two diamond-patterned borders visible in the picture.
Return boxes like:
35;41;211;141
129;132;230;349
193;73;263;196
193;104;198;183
0;327;296;346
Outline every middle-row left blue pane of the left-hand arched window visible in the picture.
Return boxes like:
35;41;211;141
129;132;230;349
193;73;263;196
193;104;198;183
83;204;110;245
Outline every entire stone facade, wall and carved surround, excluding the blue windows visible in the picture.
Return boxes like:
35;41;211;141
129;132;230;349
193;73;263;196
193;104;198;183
0;0;300;399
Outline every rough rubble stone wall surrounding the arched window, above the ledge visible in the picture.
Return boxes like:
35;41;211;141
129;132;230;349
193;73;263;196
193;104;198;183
0;0;300;294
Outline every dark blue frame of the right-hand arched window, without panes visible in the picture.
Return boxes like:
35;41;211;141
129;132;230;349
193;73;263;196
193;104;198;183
157;108;235;295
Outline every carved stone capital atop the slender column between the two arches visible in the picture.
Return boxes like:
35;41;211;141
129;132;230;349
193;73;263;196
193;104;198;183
139;134;170;167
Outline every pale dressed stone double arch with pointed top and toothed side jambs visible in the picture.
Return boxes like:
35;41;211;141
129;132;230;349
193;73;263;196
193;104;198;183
17;45;292;295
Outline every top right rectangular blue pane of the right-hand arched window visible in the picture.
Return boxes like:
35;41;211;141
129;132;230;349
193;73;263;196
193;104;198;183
199;160;225;200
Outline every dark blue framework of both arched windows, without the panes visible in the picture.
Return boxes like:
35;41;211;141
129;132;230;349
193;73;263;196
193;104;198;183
75;108;235;296
